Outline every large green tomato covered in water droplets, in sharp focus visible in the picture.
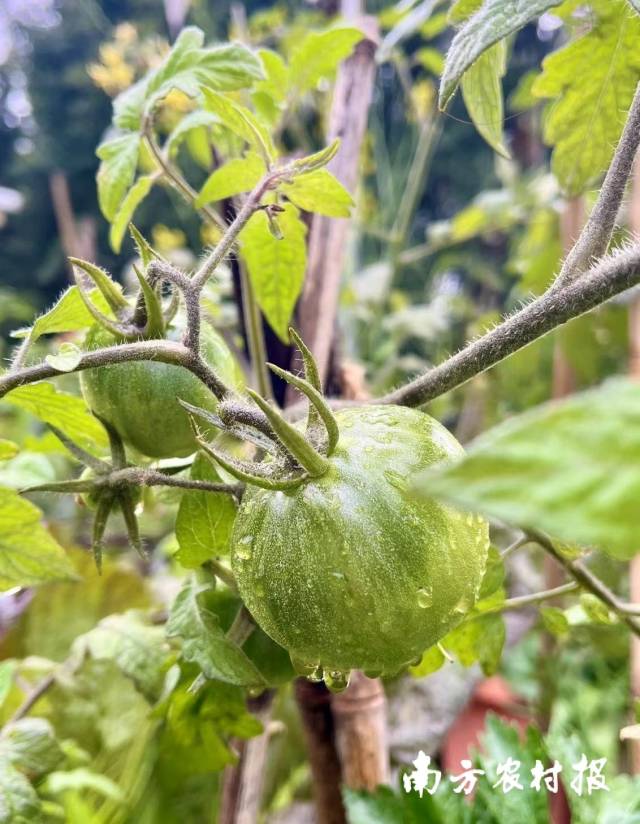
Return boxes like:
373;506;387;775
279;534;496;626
231;406;489;685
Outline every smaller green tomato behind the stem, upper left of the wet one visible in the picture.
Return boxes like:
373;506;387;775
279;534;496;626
80;325;242;458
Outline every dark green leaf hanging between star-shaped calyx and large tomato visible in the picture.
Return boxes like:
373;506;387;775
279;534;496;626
176;454;237;569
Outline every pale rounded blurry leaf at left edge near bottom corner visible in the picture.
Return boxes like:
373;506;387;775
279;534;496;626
0;718;64;779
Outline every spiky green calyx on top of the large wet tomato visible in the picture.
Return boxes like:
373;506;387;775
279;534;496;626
182;329;340;490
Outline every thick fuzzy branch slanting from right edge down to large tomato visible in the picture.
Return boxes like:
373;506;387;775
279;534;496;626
379;246;640;406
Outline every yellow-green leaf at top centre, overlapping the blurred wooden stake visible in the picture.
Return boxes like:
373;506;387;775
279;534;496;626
288;26;363;97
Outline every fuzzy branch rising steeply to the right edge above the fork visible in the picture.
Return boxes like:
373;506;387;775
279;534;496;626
553;84;640;289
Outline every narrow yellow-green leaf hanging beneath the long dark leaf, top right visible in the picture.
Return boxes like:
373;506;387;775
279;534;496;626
461;40;510;158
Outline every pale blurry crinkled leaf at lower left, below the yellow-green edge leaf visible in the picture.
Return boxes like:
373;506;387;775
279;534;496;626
72;610;169;699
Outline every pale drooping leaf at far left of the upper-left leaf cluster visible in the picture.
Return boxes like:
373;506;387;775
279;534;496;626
96;133;140;221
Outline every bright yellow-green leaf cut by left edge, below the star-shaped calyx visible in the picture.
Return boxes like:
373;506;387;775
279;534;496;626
0;487;75;591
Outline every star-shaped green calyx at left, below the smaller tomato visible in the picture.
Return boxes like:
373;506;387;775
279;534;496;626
21;416;146;572
